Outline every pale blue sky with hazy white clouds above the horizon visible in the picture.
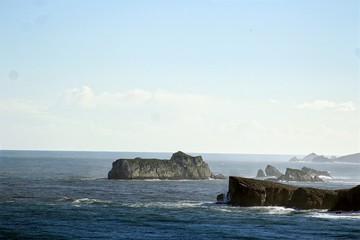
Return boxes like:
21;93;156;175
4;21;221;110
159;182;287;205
0;0;360;155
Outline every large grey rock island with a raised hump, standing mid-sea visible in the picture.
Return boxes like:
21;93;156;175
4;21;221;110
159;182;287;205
108;152;224;179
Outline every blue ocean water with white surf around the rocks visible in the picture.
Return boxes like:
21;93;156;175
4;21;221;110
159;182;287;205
0;150;360;240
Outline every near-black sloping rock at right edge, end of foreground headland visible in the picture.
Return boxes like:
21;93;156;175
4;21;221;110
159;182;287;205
330;185;360;211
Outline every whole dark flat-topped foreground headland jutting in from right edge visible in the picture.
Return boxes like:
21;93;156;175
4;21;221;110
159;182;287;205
218;176;360;211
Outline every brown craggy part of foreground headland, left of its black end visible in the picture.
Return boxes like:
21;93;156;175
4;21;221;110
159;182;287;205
227;176;337;209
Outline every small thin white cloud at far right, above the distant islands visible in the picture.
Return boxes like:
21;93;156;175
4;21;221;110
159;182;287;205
294;100;357;111
